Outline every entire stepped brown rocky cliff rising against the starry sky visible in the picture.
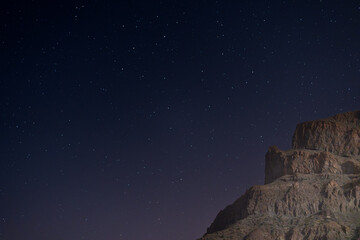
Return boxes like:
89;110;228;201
201;111;360;240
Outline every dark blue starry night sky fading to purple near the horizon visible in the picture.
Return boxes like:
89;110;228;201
0;0;360;240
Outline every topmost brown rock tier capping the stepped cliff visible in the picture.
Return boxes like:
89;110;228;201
292;111;360;156
